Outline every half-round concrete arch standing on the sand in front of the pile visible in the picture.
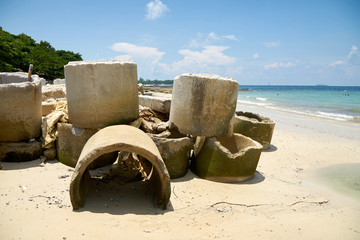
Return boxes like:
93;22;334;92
70;125;171;210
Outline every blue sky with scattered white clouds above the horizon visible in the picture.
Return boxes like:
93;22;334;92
0;0;360;86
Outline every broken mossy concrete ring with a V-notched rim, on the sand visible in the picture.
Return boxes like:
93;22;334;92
191;133;262;182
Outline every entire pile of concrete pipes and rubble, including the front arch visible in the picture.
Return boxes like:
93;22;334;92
0;60;275;210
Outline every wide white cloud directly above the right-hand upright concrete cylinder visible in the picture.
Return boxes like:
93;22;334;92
159;46;241;75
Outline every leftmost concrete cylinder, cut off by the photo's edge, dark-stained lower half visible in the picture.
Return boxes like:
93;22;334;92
0;73;41;142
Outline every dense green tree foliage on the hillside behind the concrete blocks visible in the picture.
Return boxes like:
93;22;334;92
0;27;82;79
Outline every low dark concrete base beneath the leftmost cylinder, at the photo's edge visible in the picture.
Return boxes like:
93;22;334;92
0;141;42;162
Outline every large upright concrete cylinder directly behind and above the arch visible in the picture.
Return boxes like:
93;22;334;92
64;60;139;128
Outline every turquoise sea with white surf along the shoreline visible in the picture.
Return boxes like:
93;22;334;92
238;85;360;124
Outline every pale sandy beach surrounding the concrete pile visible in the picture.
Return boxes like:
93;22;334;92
0;101;360;239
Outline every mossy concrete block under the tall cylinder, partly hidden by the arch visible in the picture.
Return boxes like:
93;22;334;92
56;123;98;167
